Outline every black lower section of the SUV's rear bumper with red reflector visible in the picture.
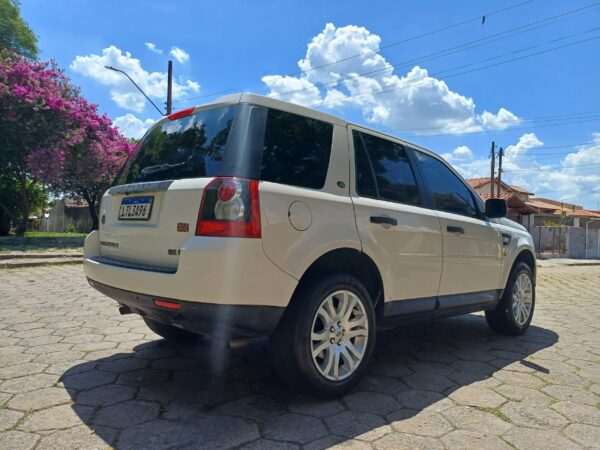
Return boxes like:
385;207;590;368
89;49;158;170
88;279;284;339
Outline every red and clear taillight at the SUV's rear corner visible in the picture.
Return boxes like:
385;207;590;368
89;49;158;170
196;177;261;238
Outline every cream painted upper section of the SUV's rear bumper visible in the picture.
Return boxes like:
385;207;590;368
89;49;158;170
83;231;298;308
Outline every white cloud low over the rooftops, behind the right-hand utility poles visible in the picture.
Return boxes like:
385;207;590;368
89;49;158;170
443;133;600;209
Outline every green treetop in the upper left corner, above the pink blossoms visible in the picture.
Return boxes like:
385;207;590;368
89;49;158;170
0;0;39;58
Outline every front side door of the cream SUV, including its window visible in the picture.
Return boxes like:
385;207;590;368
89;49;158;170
414;150;503;302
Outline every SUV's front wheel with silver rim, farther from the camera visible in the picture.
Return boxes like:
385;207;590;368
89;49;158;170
485;262;535;336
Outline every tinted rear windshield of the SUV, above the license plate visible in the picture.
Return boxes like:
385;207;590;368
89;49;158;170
114;105;238;185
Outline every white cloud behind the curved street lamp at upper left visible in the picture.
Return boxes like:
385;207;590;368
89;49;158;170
70;45;200;113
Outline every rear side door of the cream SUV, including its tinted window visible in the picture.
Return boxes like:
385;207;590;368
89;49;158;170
349;127;442;314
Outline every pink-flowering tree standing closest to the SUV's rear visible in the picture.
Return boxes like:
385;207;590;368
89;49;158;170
29;98;135;229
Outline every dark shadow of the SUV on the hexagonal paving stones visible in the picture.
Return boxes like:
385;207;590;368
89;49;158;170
61;314;558;449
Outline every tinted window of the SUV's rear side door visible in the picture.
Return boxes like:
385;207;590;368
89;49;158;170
352;131;421;205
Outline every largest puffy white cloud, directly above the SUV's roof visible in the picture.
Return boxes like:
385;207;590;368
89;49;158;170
263;23;520;134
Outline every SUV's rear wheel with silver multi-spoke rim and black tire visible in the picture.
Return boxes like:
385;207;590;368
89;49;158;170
271;274;375;398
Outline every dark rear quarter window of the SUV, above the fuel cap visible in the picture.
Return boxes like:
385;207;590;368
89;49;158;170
260;109;333;189
